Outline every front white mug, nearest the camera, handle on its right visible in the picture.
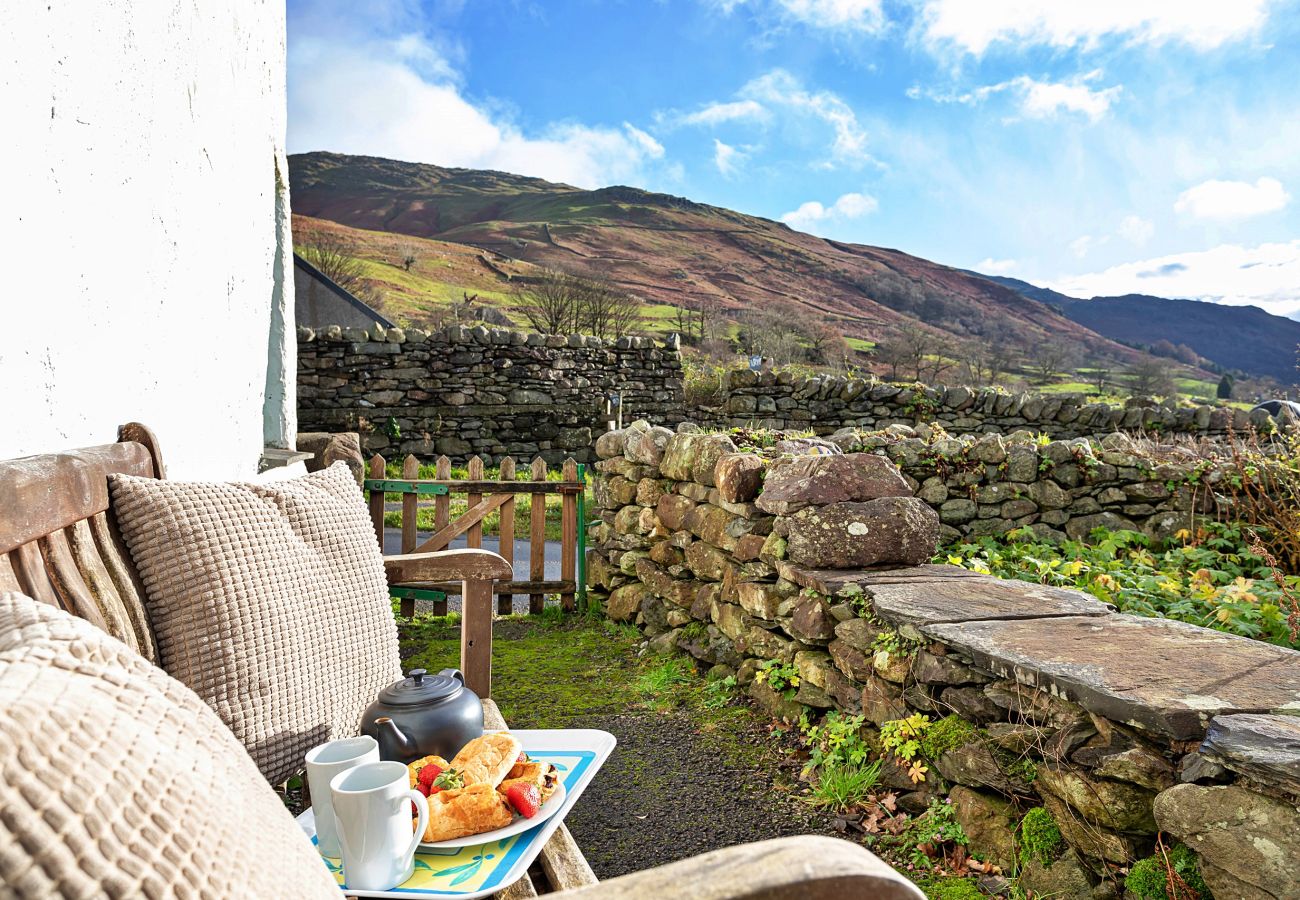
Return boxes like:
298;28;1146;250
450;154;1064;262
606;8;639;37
329;761;429;891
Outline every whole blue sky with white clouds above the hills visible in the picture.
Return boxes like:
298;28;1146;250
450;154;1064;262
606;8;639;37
289;0;1300;315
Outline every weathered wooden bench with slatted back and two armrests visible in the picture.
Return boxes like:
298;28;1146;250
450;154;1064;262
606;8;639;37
0;424;924;900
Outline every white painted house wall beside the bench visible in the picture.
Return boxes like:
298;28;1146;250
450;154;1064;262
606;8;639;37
0;0;296;479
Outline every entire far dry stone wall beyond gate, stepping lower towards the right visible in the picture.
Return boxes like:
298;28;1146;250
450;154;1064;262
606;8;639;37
298;325;1273;463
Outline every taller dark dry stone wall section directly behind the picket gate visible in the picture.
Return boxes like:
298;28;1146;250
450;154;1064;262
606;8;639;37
298;325;683;462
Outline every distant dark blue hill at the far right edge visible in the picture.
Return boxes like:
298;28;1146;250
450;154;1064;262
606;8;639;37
987;276;1300;384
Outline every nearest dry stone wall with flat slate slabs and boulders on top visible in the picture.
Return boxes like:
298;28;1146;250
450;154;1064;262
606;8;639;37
589;423;1300;900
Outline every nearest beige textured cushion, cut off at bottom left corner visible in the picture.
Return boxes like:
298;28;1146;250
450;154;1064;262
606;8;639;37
0;593;338;897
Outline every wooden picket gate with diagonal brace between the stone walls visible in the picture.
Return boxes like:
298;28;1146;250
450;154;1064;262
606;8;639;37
365;454;586;615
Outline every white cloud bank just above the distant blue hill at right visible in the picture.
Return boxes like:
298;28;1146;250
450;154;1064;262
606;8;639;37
1050;239;1300;316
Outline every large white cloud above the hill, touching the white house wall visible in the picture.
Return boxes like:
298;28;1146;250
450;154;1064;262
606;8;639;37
289;35;664;187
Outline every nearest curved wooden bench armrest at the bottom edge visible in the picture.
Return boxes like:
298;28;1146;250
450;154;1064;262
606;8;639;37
550;835;926;900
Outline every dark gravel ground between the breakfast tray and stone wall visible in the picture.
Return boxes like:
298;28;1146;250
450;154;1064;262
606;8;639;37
566;713;833;879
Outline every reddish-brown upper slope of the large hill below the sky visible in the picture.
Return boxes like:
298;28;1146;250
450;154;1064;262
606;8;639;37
290;152;1136;362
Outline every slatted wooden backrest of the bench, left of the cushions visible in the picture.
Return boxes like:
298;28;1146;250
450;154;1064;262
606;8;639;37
0;425;161;662
